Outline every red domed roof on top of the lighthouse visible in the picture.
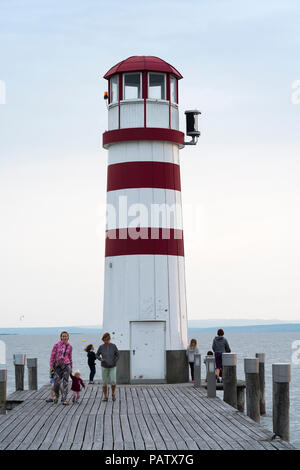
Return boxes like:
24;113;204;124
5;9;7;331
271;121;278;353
104;55;182;80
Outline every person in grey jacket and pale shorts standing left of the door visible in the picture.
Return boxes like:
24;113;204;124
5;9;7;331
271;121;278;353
96;333;120;401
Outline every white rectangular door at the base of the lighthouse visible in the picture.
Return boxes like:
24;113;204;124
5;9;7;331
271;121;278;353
130;321;166;382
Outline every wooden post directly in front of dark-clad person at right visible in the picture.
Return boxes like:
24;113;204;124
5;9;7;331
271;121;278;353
222;353;237;408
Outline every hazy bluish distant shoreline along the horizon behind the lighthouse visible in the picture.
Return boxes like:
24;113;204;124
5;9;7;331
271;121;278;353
0;322;300;336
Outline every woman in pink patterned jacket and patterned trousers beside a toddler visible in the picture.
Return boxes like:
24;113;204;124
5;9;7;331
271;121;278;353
50;331;73;405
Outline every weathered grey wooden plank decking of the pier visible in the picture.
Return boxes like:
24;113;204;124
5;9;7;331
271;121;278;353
0;384;293;450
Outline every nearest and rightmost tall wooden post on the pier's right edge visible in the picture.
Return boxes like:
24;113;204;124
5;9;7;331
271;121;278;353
272;364;291;441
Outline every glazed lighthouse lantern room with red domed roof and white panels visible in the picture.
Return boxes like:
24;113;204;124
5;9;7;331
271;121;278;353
104;56;182;131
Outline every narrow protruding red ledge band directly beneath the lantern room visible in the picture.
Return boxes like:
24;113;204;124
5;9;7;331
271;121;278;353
103;127;184;148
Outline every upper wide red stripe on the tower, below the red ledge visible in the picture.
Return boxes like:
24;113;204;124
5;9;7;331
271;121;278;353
107;162;181;191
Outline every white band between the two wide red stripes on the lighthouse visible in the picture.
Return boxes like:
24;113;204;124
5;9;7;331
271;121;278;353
106;188;183;230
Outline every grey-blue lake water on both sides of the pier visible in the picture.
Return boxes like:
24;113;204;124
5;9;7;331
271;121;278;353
0;332;300;448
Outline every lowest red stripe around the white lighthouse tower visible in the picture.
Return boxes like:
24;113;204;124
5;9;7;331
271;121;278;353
105;227;184;257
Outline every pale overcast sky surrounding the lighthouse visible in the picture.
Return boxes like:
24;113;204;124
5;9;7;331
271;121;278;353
0;0;300;326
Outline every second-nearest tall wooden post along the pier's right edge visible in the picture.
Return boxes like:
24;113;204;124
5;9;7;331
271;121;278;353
244;358;260;423
